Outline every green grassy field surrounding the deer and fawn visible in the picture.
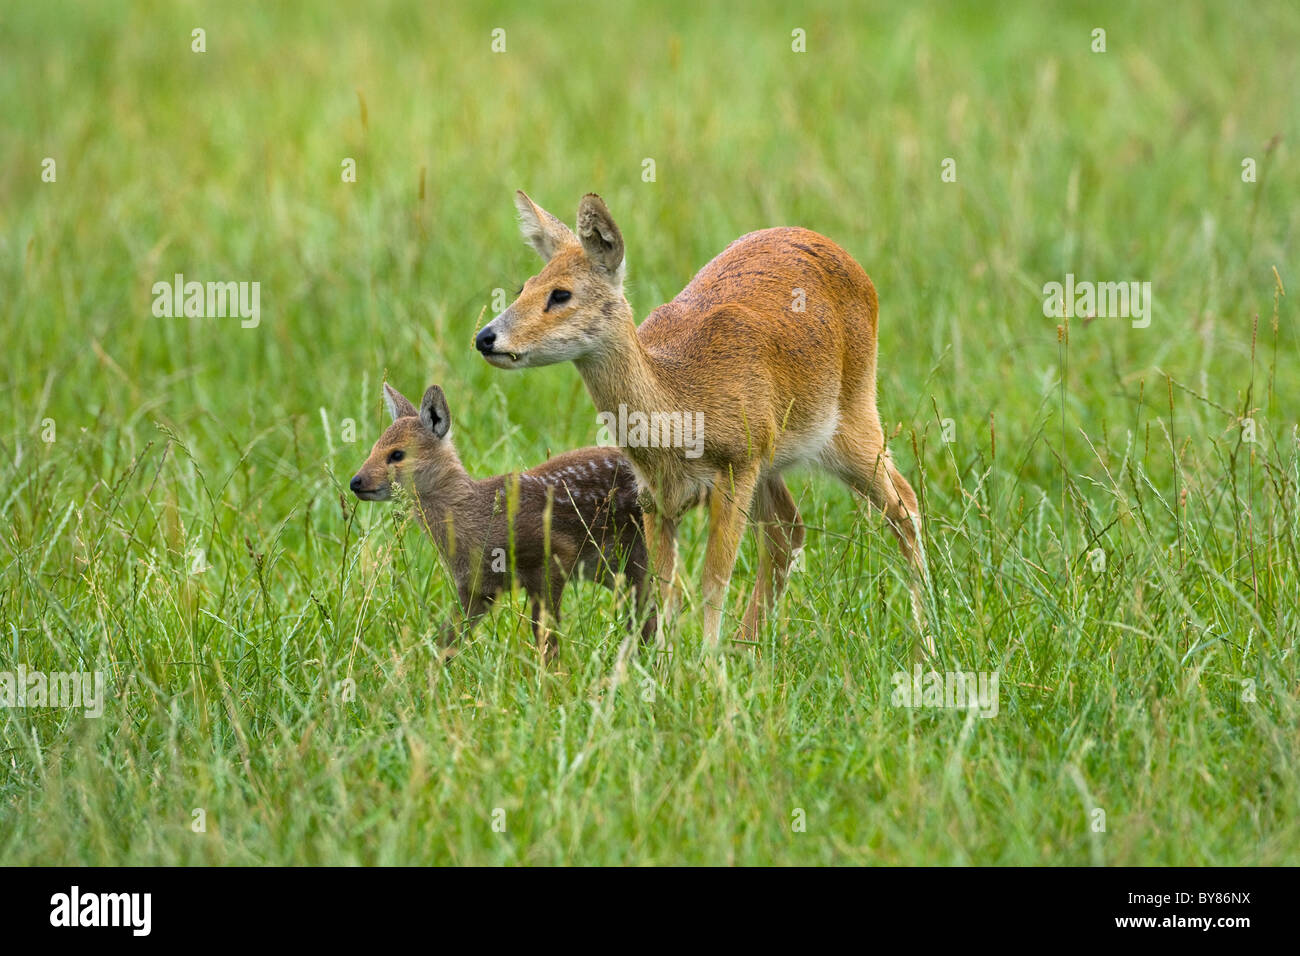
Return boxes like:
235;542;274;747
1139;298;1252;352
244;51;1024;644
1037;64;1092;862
0;0;1300;865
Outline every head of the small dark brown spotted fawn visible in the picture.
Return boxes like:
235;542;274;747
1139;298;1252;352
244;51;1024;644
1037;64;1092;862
348;382;464;501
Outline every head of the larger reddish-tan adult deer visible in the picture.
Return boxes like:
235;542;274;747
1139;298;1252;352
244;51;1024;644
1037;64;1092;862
475;191;632;368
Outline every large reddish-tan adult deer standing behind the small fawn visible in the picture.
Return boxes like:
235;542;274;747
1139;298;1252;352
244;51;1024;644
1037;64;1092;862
475;191;933;653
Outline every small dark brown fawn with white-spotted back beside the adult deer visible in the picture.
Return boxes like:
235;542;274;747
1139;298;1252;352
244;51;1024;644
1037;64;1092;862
350;382;655;661
